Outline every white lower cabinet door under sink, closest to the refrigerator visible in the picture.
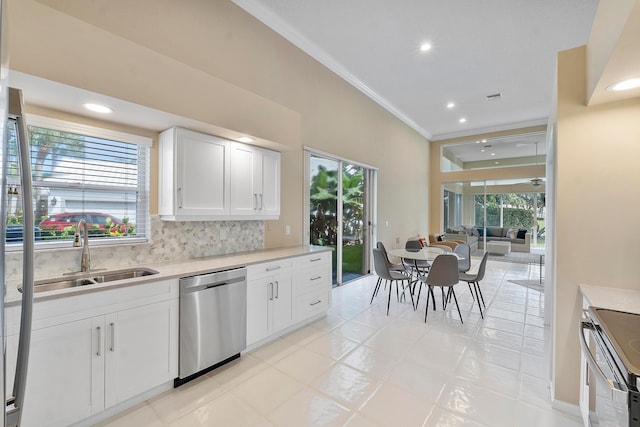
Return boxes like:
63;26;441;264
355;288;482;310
22;316;105;427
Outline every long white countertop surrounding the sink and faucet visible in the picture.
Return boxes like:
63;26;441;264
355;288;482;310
5;245;332;306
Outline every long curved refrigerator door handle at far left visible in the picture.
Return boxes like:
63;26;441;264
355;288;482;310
7;88;35;426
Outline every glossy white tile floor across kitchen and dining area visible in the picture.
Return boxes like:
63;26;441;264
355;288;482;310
102;261;582;427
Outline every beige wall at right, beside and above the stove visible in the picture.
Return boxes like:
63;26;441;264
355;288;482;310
553;47;640;404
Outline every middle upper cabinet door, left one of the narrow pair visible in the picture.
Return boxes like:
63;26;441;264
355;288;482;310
230;143;262;215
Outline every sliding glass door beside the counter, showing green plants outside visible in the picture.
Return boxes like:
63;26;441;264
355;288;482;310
308;153;374;285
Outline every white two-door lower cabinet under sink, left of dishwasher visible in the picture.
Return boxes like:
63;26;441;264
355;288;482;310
22;281;179;427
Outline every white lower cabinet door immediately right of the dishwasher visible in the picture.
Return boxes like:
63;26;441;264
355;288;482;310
247;277;273;345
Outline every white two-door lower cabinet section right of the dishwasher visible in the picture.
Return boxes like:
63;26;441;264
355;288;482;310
247;260;293;345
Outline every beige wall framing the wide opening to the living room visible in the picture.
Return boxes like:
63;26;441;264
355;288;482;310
429;126;546;233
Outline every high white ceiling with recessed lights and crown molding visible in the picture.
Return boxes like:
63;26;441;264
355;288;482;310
233;0;598;140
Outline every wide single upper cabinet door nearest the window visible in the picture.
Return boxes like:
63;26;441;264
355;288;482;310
176;129;230;216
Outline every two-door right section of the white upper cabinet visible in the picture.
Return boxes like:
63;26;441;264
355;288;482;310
231;142;280;219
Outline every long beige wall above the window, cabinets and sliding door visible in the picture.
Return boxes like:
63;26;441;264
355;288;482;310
9;0;429;252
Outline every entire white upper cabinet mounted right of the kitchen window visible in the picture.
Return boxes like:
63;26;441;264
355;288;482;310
158;128;280;221
